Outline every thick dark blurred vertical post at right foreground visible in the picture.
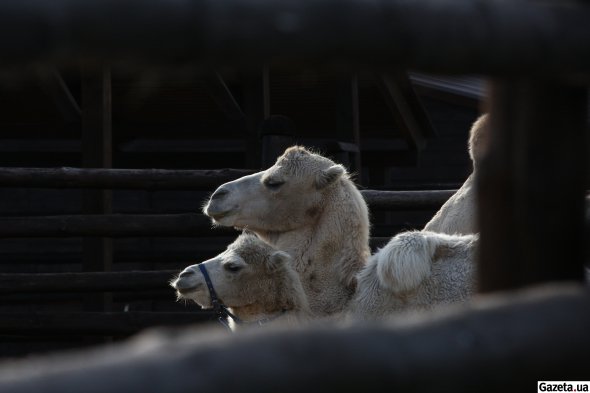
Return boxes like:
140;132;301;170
478;79;588;292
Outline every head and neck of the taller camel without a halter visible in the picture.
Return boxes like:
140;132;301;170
204;146;370;316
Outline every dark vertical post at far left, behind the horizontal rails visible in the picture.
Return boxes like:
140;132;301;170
82;65;113;311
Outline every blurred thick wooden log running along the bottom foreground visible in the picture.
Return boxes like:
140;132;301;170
0;287;590;393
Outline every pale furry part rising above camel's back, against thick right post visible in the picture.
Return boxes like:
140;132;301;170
424;115;488;234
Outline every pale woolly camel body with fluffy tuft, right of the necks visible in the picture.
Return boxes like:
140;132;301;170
349;231;478;319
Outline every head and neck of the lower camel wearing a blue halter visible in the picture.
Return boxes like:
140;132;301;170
171;233;311;330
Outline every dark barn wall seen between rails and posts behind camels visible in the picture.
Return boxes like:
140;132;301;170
0;66;478;357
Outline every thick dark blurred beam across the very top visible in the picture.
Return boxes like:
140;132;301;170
0;0;590;74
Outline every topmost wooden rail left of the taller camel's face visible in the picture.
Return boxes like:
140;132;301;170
0;168;254;190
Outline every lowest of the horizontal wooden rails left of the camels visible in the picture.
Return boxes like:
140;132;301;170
0;307;213;336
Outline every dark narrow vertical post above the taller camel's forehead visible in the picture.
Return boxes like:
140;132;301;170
242;66;270;168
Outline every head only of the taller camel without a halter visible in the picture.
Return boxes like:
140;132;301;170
203;146;347;233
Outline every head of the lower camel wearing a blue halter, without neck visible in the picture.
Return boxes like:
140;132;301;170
171;233;297;308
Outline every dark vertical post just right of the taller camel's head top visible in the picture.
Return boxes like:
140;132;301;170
336;74;362;183
